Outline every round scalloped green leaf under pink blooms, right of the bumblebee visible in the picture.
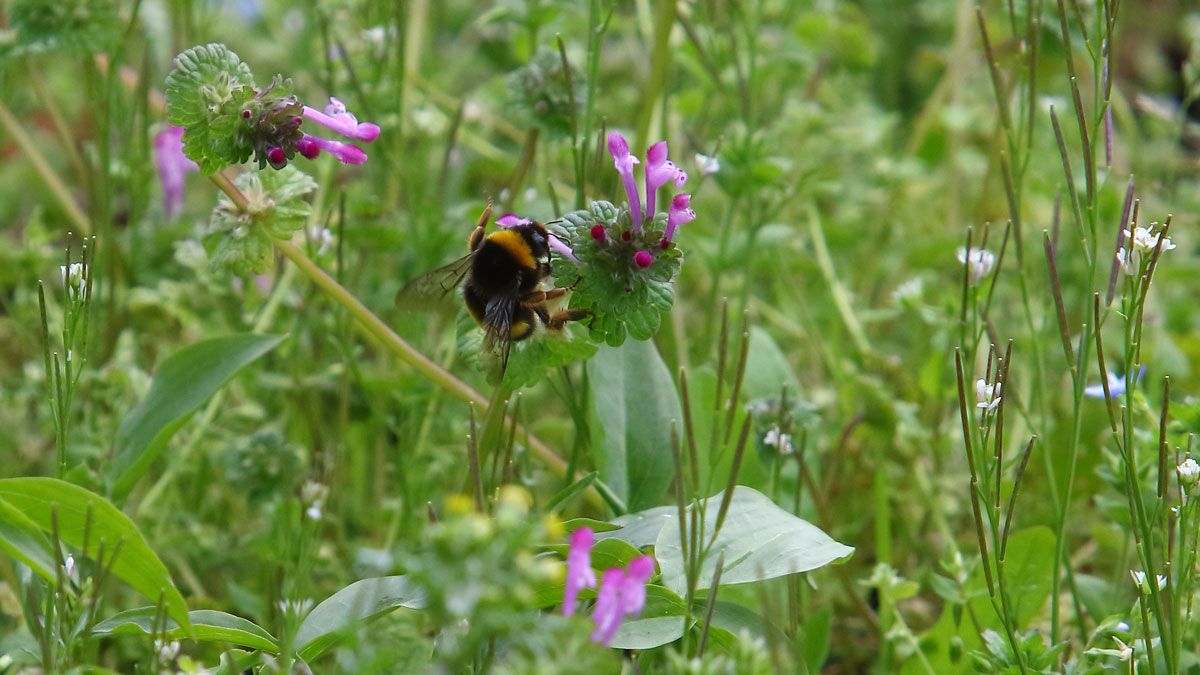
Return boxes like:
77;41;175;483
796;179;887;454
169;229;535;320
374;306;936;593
550;202;683;347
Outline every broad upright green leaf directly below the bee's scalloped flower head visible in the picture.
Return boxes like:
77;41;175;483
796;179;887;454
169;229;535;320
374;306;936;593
588;342;682;509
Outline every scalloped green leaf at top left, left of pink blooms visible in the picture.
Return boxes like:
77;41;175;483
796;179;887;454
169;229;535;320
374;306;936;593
166;43;256;173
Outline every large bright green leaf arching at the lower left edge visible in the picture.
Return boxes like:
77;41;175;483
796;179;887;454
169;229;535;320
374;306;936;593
0;478;190;632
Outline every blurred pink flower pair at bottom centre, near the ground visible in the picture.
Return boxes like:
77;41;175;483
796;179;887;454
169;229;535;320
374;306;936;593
563;527;654;646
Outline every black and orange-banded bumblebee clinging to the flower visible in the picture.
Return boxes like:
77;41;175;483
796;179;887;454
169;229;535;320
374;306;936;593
396;202;588;372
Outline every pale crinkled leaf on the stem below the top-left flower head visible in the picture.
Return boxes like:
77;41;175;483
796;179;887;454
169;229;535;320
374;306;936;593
205;166;317;276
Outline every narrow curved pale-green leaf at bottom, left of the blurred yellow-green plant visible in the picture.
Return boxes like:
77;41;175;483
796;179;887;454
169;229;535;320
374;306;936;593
295;577;425;661
